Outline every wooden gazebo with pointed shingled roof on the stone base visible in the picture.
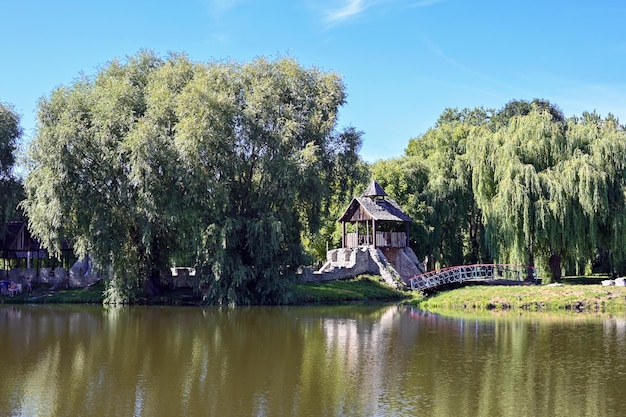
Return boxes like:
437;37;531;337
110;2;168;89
337;181;412;248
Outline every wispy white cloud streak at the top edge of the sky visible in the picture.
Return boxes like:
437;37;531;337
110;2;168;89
318;0;445;26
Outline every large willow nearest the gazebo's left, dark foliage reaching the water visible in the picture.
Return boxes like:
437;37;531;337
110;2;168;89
176;59;358;304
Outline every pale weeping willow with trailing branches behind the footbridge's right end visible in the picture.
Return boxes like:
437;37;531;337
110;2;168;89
472;106;564;276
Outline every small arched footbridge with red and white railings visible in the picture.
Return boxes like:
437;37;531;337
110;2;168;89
409;264;538;291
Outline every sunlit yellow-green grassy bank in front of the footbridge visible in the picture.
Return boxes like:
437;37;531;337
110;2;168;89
412;284;626;313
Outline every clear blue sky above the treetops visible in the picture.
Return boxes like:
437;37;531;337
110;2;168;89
0;0;626;162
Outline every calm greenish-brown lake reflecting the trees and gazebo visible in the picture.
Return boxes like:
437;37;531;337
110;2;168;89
0;305;626;417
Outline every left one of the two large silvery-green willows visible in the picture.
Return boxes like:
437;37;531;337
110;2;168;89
23;52;182;303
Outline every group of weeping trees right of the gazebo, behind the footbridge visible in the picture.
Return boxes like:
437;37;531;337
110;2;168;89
373;99;626;280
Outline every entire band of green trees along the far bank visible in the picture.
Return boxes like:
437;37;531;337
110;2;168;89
0;51;626;305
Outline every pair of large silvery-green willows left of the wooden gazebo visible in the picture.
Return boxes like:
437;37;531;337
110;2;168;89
24;51;351;304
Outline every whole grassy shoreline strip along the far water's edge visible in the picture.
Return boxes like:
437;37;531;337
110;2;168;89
0;275;626;313
